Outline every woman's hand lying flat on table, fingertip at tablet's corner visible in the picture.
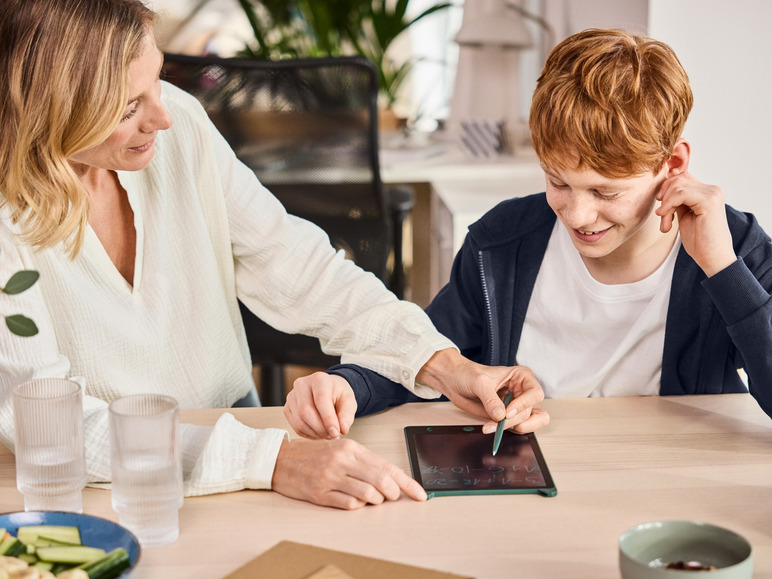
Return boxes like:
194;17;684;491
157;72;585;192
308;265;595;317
271;438;426;509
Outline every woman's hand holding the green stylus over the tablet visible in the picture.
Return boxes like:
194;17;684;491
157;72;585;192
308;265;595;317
417;349;549;432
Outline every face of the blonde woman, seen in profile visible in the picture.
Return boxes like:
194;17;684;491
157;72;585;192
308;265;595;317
69;35;172;172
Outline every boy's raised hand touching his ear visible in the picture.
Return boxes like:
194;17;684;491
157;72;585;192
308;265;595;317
655;172;737;277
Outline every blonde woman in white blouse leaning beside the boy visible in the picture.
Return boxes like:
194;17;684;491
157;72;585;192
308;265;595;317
0;0;540;508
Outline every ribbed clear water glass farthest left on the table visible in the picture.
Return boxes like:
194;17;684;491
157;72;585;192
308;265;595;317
13;378;86;513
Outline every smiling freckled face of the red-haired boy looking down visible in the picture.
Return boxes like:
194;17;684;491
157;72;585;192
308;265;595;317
542;166;669;273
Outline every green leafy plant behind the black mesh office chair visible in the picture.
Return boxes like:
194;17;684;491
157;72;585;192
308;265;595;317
239;0;451;108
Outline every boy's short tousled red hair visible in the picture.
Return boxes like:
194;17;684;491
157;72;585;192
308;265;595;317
529;29;693;178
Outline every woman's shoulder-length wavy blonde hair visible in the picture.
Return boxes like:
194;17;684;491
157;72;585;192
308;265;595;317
0;0;154;256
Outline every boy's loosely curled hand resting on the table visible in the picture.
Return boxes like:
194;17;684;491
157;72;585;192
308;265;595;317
284;372;357;439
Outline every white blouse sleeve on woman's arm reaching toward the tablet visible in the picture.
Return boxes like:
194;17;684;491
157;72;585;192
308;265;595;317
198;101;454;397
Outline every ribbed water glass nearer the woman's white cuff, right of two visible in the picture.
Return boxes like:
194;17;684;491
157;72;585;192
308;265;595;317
110;394;183;547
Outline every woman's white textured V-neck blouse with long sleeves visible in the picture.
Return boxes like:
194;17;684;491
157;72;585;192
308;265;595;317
0;83;454;495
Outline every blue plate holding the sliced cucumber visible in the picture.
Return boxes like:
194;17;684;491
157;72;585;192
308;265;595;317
0;511;140;578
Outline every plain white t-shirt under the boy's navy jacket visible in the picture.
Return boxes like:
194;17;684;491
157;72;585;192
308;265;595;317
517;221;681;398
